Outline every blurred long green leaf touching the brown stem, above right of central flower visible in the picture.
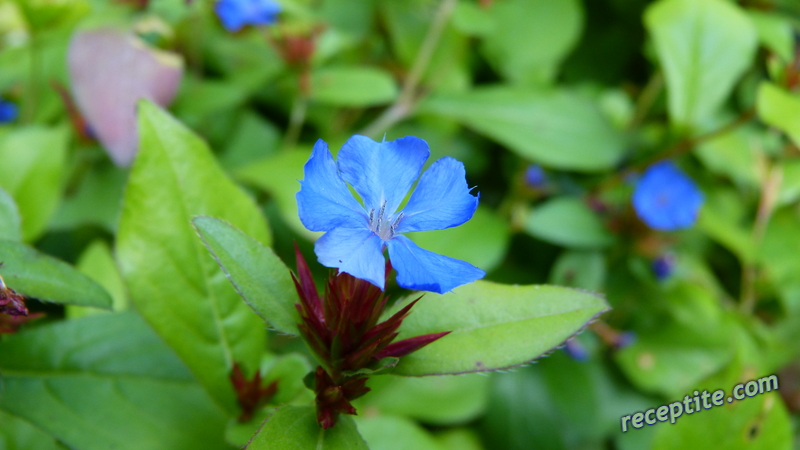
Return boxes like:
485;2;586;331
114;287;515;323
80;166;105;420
418;86;625;172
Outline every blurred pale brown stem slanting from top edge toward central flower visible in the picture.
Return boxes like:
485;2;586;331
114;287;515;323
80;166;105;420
360;0;456;137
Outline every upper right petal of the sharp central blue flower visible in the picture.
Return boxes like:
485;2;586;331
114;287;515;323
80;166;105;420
397;157;480;233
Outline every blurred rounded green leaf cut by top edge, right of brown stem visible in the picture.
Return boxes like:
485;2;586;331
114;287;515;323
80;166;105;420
481;0;583;85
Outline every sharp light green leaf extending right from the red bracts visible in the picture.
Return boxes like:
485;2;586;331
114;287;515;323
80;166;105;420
392;281;608;376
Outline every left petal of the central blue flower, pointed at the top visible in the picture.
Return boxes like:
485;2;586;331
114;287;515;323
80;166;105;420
296;139;369;231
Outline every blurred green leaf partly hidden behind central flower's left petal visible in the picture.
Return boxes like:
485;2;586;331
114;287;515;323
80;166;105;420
236;149;322;240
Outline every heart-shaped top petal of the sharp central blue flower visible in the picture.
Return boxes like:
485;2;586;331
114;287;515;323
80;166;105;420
338;135;430;216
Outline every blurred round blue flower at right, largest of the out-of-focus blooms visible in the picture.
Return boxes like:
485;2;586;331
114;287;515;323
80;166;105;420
633;161;703;231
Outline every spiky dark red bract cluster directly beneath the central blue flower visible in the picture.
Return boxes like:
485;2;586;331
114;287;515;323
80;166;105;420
292;246;449;429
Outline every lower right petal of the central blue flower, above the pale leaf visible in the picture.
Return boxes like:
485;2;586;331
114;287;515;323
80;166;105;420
387;235;486;294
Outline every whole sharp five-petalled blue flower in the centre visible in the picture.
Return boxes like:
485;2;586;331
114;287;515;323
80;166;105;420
297;135;485;294
